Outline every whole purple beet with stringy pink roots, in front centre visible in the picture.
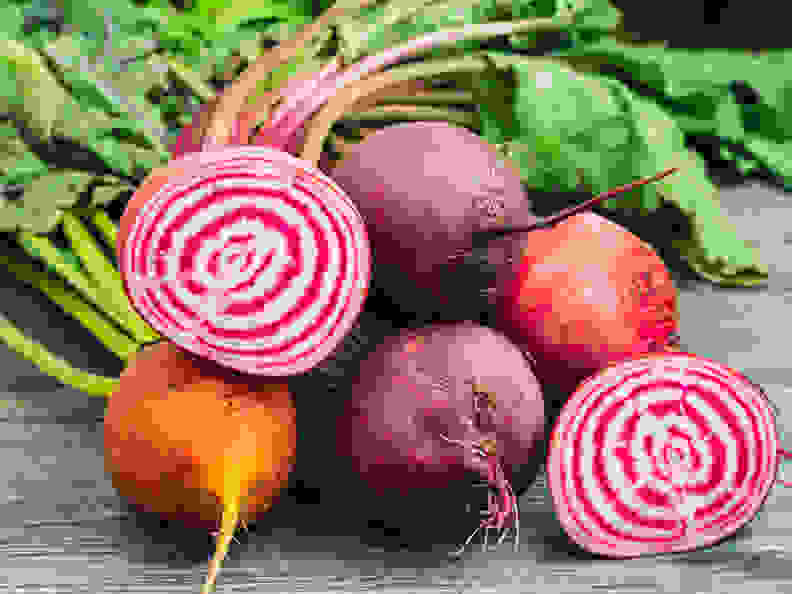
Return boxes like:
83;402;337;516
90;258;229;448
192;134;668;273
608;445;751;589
336;322;545;552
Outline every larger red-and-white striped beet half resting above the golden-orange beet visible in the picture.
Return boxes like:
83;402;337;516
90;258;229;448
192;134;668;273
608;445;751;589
118;146;370;376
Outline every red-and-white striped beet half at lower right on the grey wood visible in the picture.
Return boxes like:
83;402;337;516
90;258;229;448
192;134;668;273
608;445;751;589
547;353;780;558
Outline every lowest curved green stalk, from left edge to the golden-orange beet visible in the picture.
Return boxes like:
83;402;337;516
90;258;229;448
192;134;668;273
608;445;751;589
0;314;118;396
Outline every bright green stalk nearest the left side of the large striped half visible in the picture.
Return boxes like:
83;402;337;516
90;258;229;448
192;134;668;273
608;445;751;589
62;210;159;342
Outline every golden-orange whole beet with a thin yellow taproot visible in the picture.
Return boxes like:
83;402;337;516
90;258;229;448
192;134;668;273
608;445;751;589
104;342;297;592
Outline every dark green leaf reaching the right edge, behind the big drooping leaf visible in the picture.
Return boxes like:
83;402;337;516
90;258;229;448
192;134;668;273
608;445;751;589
555;38;792;184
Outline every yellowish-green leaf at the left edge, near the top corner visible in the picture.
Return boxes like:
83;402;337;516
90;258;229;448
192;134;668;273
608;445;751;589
0;38;68;140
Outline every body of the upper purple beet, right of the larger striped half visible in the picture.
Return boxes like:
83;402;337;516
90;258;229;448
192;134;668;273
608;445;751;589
330;122;536;317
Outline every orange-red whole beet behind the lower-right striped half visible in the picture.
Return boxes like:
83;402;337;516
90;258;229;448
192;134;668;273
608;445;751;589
470;212;679;400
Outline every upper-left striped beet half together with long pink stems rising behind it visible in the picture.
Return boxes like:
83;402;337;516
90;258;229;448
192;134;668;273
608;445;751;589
118;0;604;375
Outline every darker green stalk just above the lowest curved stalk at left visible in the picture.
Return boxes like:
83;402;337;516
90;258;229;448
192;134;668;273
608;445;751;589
0;253;139;362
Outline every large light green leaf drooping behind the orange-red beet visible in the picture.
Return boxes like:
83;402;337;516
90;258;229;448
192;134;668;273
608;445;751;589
503;58;767;285
